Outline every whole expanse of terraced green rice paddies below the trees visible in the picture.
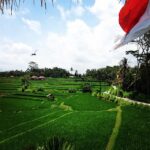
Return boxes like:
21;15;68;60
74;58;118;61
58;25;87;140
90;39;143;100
0;78;150;150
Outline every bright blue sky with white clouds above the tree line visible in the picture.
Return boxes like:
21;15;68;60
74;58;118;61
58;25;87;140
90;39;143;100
0;0;134;73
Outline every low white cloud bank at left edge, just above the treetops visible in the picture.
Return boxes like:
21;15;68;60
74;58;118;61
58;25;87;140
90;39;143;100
0;39;32;70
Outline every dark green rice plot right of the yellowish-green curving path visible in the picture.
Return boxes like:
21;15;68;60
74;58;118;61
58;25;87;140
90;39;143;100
114;106;150;150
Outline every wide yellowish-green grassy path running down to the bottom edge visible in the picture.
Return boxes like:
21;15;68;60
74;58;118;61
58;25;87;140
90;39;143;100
106;106;122;150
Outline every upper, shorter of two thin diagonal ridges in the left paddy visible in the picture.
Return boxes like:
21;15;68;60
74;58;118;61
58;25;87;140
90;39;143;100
1;111;60;133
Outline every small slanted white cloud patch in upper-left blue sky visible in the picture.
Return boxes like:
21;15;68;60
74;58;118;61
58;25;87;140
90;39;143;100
22;17;41;34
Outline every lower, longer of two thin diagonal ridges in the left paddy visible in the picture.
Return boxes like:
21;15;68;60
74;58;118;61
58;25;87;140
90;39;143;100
0;112;73;144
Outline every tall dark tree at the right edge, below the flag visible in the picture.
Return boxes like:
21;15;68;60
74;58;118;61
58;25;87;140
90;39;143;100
126;31;150;95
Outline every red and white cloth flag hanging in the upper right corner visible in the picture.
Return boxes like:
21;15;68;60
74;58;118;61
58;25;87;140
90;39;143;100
115;0;150;49
